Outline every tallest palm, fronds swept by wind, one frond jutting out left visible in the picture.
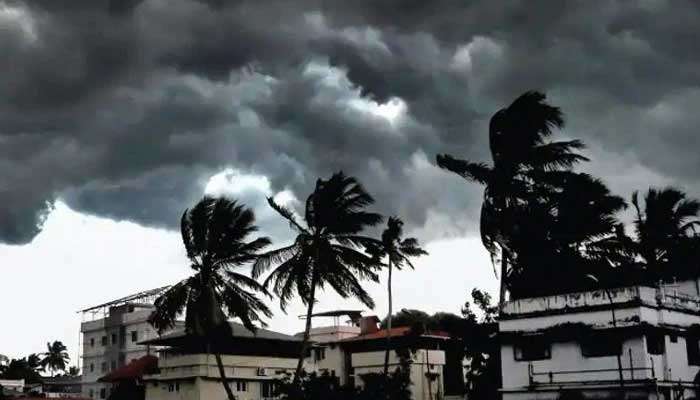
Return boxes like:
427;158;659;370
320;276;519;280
437;91;587;302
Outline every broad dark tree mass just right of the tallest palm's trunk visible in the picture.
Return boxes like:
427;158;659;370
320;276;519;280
508;171;627;298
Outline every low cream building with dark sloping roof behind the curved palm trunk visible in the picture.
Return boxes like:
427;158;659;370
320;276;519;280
143;323;301;400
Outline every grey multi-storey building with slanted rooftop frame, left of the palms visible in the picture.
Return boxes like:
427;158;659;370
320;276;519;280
80;287;167;399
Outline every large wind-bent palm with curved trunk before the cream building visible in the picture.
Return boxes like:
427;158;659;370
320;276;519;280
150;197;272;400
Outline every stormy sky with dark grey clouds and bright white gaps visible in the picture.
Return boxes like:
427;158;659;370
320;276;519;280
0;0;700;357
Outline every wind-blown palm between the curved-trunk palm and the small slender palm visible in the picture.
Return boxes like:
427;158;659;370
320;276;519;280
253;172;382;384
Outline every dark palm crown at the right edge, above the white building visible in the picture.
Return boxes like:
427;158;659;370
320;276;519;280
632;187;700;283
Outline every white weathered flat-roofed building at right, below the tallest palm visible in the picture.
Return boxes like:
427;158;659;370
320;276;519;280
499;281;700;400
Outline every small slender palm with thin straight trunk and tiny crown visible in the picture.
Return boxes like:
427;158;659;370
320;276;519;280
368;217;428;377
